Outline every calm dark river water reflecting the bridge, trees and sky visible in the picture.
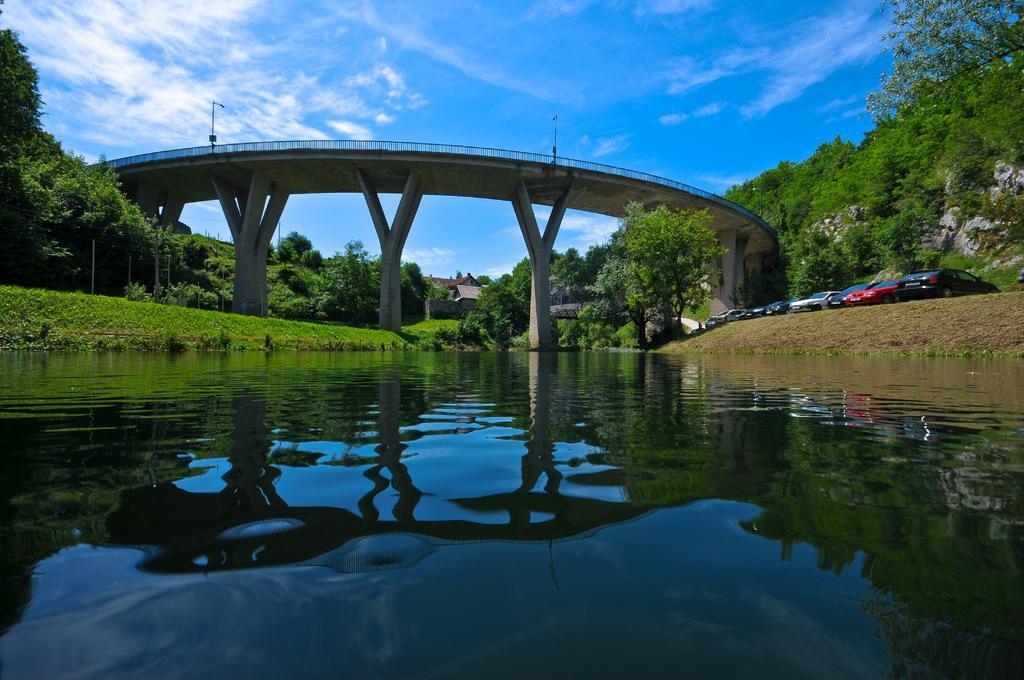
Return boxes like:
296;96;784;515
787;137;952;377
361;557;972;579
0;353;1024;678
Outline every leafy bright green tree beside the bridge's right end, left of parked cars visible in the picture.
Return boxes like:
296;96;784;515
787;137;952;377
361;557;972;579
626;204;726;333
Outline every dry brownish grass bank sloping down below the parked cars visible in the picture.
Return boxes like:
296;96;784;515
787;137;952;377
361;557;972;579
663;292;1024;356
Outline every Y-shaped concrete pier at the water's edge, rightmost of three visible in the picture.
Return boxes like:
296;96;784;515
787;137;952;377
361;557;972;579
512;179;572;349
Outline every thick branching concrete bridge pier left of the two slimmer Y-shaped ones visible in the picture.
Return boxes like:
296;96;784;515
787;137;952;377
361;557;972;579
212;172;288;316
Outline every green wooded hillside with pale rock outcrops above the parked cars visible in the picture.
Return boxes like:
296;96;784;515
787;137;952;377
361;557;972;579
726;0;1024;304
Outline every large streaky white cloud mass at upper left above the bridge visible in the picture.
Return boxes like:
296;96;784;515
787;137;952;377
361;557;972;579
4;0;422;146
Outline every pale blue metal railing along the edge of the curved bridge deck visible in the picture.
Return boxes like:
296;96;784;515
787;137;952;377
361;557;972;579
106;139;774;235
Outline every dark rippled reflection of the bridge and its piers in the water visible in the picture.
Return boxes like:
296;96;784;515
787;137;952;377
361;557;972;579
108;353;663;571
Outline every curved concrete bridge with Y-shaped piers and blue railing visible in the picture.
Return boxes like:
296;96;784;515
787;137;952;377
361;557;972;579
110;140;777;347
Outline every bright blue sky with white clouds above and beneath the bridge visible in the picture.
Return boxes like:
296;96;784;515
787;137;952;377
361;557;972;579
6;0;888;274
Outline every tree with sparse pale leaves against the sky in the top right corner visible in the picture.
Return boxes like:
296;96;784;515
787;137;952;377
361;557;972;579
867;0;1024;118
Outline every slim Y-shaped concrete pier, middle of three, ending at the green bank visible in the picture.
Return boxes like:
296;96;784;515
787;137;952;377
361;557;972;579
355;169;423;333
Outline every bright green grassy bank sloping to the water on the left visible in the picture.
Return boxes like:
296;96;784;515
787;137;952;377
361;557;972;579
0;286;451;350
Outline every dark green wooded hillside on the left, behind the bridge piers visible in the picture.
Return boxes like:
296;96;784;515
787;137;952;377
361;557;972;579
0;12;440;324
